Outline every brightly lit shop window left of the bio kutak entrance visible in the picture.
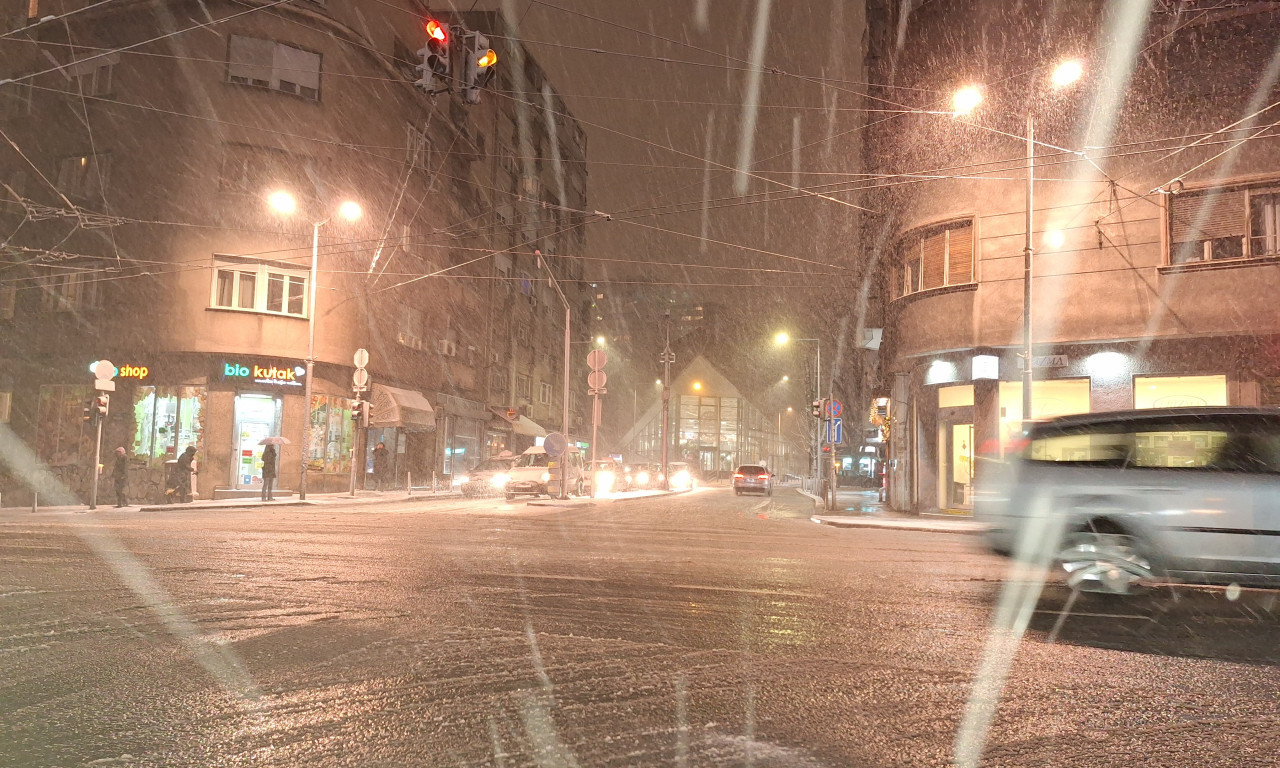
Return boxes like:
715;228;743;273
132;387;207;466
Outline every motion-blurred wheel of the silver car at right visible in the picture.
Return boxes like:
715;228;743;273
1056;524;1155;595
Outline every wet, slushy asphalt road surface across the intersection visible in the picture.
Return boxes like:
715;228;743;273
0;489;1280;768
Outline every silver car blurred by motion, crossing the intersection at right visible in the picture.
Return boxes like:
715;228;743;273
974;407;1280;594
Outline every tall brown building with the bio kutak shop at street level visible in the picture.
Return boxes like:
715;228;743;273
0;0;590;503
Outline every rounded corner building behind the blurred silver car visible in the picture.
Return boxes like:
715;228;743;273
867;0;1280;513
